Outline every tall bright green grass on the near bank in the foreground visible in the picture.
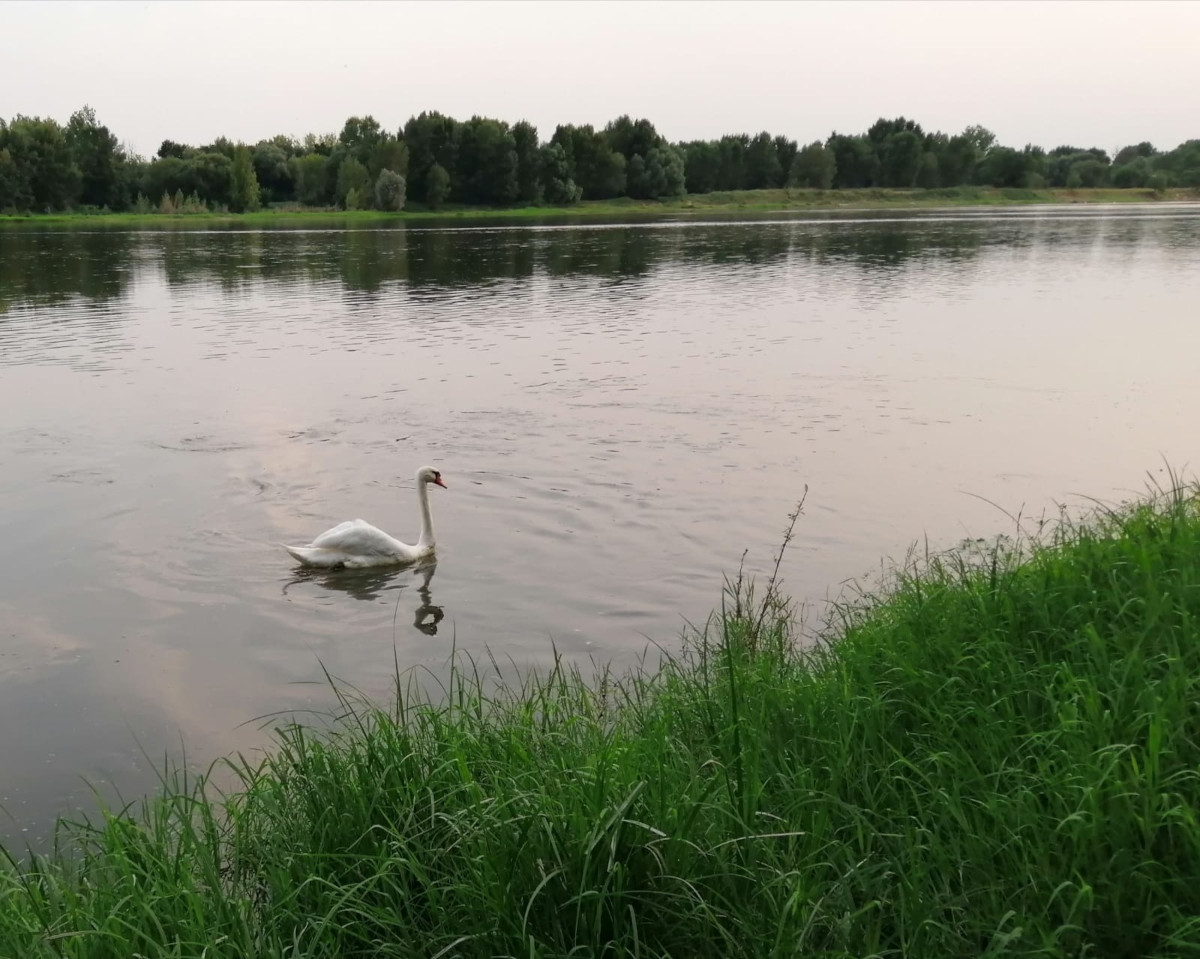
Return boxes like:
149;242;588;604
0;486;1200;959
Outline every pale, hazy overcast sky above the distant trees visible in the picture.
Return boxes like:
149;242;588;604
0;0;1200;156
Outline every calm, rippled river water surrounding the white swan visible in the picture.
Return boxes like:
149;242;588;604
0;206;1200;843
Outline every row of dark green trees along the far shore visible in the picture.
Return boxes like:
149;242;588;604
0;107;1200;212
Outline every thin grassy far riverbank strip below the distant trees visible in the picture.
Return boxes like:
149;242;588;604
0;187;1200;228
